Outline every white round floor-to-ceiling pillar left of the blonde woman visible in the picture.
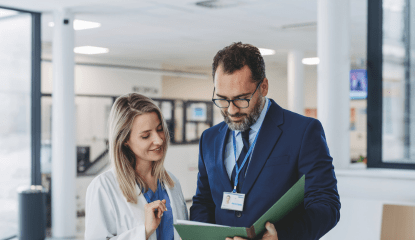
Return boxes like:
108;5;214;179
52;10;76;239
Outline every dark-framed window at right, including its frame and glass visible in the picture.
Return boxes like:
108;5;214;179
367;0;415;169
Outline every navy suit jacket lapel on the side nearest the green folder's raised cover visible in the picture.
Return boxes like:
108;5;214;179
241;99;283;194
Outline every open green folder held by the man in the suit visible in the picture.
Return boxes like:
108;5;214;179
174;175;305;240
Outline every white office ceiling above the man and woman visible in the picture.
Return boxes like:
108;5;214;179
0;0;367;72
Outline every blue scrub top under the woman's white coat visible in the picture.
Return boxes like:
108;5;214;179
141;180;174;240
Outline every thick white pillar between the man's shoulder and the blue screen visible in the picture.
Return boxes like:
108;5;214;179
317;0;351;169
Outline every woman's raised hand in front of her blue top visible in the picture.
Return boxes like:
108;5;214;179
144;199;167;239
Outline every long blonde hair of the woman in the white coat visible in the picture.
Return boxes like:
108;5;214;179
108;93;174;204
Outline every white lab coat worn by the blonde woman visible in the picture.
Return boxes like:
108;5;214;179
85;169;188;240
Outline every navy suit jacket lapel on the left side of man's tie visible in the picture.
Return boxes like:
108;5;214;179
215;124;233;191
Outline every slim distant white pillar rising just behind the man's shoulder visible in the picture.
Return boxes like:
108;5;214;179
287;50;304;115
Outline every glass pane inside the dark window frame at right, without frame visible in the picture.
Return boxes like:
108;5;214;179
382;0;415;164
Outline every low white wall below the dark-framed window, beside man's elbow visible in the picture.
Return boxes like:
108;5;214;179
322;169;415;240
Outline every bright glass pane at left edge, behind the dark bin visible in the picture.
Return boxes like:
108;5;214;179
0;8;32;239
